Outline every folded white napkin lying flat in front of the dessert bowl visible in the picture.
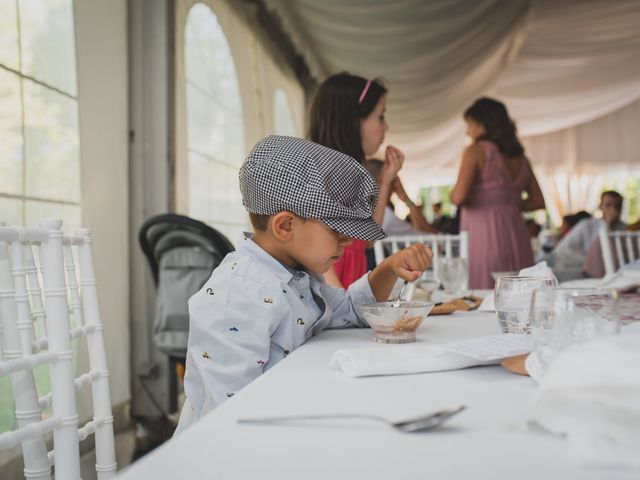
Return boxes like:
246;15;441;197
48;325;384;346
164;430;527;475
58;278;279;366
329;334;532;377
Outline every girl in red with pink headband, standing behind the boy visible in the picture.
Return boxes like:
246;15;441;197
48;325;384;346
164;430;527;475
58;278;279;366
309;73;404;288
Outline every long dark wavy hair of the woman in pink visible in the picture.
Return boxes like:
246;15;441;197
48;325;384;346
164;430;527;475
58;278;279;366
464;97;524;157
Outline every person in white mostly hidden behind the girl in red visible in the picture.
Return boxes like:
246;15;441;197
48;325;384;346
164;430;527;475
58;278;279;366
365;158;440;236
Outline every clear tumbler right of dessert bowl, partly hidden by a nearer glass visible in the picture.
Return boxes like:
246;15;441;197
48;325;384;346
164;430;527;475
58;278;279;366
494;277;556;333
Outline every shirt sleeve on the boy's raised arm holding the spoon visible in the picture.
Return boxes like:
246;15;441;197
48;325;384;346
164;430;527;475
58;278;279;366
322;273;376;328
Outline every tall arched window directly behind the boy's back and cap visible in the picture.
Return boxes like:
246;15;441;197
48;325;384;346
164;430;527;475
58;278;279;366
184;3;247;241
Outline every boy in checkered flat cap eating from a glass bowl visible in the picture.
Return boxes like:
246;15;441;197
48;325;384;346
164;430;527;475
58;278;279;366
178;135;431;430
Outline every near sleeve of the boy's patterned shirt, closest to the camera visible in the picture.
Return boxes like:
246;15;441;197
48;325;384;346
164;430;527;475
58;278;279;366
185;276;284;417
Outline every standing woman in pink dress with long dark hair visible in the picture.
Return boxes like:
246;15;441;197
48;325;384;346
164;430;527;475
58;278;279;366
451;98;545;288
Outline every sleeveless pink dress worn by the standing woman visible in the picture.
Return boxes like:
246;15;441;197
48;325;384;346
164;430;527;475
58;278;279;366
460;141;533;288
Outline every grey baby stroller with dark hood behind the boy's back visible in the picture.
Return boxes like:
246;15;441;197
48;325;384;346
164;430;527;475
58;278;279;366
138;213;234;412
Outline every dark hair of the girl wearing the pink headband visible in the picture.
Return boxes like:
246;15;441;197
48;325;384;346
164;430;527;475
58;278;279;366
309;72;387;164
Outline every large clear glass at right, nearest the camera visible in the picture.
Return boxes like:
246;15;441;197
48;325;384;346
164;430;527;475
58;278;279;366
531;288;621;372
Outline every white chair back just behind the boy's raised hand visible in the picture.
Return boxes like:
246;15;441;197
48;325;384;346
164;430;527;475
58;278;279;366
373;232;469;278
